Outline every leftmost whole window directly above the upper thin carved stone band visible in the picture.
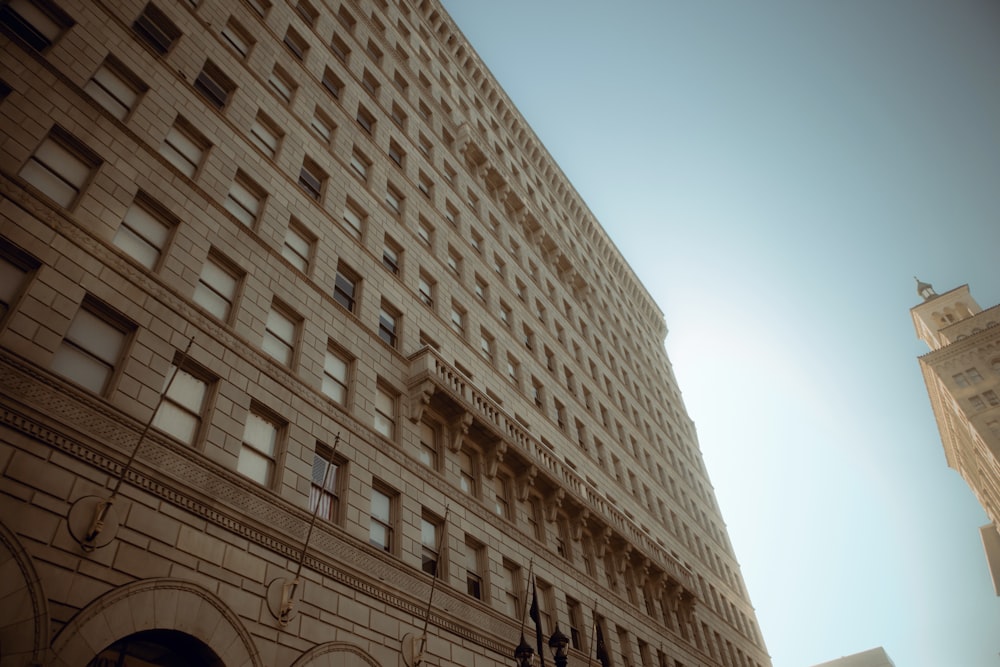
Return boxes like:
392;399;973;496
19;126;101;208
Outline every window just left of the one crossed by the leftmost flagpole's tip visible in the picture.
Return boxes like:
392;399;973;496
52;297;135;394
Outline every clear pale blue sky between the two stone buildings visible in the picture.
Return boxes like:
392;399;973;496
444;0;1000;667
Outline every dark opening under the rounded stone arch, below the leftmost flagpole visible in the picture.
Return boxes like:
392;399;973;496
87;629;224;667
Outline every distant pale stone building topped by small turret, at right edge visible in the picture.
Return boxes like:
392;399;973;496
910;281;1000;595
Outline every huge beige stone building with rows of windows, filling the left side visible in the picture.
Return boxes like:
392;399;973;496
0;0;769;667
